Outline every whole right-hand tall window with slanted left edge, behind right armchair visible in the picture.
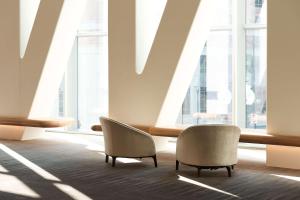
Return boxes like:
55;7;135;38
177;0;266;128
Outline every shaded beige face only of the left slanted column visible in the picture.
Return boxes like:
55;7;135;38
20;0;64;116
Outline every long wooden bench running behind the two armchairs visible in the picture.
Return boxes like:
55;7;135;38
91;125;300;147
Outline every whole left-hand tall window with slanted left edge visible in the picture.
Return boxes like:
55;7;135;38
53;0;108;131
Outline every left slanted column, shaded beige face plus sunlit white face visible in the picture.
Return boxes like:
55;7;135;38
21;0;86;117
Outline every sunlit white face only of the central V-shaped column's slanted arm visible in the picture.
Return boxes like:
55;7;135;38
156;0;218;126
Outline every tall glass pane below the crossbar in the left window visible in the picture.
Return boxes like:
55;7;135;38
78;36;108;130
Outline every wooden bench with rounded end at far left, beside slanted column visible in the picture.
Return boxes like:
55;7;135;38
0;117;73;128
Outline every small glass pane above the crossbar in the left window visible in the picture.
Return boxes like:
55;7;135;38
79;0;108;33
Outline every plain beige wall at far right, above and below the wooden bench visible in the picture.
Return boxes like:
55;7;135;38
267;0;300;169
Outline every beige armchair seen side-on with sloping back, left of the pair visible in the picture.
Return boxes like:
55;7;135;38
100;117;157;167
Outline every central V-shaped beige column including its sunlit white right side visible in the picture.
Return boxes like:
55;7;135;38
109;0;217;125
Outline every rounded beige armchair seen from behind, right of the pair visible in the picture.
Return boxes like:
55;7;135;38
176;125;241;177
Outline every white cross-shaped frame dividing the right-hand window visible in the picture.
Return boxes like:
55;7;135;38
181;0;267;130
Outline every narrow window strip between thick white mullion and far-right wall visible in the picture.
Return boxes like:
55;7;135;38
245;0;267;129
